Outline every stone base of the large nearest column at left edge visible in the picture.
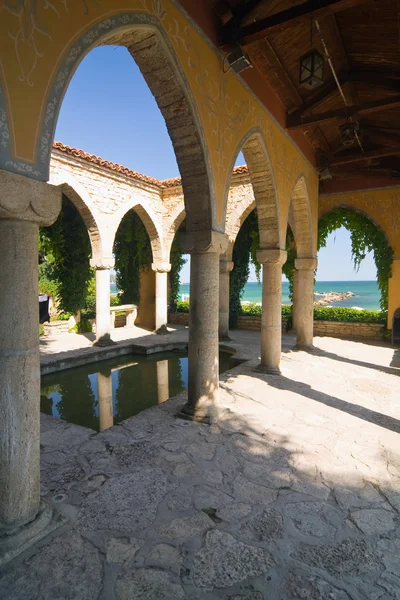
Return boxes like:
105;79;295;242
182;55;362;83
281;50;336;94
0;500;67;567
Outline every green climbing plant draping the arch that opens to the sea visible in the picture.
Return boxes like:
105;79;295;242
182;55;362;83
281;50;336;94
318;208;393;310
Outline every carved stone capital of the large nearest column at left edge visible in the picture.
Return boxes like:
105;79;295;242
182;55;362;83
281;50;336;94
0;171;62;226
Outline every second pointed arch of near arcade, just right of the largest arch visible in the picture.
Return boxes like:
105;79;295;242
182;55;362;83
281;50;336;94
225;127;282;248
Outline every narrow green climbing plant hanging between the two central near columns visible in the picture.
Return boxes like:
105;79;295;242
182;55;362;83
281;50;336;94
229;210;261;327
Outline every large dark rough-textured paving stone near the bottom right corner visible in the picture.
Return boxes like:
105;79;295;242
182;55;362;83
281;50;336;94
292;538;382;577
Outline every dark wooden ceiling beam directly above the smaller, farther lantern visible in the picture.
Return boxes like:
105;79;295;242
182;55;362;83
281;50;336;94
286;95;400;129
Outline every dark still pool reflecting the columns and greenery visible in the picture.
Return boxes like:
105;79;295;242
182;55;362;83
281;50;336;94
40;352;238;431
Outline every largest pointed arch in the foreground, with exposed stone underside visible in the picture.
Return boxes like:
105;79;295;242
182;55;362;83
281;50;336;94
32;12;216;231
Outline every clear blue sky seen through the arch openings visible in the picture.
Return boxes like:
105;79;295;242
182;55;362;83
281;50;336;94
55;46;376;282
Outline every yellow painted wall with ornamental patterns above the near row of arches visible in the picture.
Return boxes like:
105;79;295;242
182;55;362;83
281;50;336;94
0;0;318;239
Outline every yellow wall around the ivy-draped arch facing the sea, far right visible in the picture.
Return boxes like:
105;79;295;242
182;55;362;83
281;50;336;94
319;187;400;328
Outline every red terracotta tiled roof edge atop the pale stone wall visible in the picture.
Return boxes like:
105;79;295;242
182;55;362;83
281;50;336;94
53;142;248;188
